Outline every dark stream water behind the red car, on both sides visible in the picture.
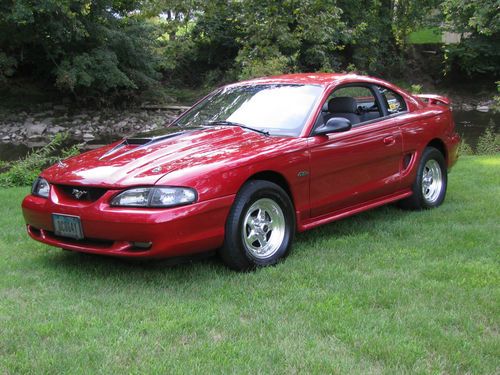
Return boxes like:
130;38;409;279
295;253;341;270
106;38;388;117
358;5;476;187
0;111;500;161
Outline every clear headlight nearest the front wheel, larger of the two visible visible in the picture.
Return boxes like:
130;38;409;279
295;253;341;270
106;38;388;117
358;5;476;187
111;187;197;207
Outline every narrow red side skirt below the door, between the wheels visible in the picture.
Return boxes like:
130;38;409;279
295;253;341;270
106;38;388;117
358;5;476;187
297;189;412;232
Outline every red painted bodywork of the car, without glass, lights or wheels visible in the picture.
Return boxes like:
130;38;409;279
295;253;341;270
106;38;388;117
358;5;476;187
22;73;460;258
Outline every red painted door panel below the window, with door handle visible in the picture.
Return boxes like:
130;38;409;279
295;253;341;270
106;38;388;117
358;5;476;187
310;119;402;217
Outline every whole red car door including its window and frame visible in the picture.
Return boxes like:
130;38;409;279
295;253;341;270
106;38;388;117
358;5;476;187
309;84;402;217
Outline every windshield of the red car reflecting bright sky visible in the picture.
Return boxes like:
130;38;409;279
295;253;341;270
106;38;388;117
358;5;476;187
175;84;323;136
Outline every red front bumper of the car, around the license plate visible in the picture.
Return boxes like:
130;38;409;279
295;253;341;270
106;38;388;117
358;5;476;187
22;186;234;258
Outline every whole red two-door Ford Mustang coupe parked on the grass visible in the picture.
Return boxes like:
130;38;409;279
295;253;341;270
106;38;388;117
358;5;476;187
22;74;459;270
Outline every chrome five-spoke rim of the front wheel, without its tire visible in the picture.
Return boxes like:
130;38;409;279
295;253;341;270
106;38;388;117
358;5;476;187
241;198;285;259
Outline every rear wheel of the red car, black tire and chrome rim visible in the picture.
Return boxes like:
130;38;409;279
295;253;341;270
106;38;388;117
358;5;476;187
399;147;448;210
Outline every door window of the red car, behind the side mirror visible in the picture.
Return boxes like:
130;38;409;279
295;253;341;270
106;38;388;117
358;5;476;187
323;85;381;126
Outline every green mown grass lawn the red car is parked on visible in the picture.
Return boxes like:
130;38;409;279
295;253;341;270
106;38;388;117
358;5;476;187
0;155;500;374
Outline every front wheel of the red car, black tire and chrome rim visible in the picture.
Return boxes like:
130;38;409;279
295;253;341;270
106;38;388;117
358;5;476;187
219;180;295;271
